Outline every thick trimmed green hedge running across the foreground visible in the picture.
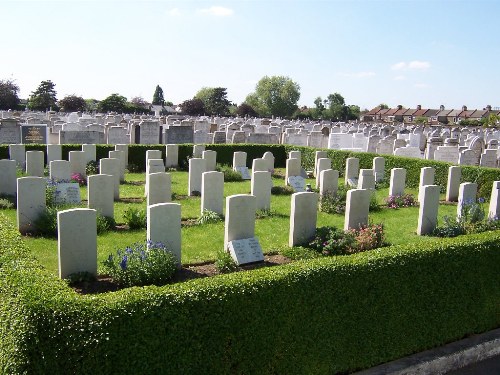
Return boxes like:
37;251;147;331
0;217;500;374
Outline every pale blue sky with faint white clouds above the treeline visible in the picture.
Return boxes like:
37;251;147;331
0;0;500;109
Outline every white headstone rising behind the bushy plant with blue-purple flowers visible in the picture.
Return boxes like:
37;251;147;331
147;203;181;268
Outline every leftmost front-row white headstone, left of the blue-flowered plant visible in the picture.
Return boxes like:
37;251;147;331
57;208;97;279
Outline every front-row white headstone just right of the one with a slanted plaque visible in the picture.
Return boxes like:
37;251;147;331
288;192;318;247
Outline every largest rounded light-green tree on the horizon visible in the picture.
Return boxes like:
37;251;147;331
245;76;300;117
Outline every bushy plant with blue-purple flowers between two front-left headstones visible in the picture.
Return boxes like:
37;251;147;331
102;241;177;287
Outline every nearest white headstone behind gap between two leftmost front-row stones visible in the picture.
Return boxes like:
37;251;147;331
87;174;115;218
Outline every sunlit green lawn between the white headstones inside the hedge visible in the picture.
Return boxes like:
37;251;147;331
4;171;462;273
